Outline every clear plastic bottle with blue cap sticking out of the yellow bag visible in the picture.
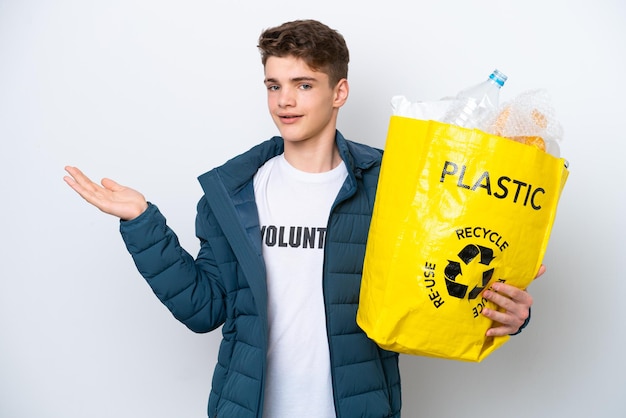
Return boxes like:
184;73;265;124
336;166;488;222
443;69;508;130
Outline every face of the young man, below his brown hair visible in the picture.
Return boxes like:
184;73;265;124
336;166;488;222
265;57;348;147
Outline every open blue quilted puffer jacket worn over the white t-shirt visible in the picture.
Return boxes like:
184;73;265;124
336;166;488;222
120;132;401;418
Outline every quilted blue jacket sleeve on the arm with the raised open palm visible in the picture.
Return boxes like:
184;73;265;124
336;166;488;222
120;204;226;332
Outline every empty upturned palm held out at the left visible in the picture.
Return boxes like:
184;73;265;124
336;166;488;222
63;166;148;221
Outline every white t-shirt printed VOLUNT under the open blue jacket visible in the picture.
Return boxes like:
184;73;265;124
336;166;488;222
254;155;347;418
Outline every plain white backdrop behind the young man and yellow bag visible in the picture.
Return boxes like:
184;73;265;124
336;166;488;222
0;0;626;418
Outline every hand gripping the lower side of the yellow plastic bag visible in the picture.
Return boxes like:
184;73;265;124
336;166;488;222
482;264;546;337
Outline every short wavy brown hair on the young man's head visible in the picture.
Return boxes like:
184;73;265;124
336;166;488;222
258;20;350;86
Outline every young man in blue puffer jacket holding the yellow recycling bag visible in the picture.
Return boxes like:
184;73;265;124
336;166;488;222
65;20;532;418
